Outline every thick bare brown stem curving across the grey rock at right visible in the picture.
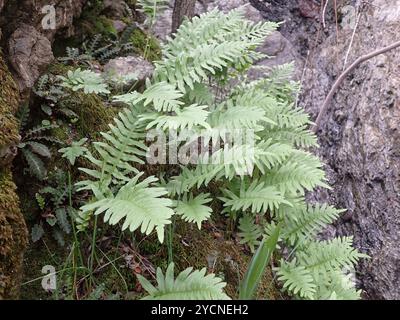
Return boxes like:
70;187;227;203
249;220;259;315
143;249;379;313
312;41;400;133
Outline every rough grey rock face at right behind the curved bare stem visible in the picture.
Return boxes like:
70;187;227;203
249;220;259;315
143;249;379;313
253;0;400;299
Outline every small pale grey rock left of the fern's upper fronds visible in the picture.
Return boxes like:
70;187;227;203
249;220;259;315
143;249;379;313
104;56;154;83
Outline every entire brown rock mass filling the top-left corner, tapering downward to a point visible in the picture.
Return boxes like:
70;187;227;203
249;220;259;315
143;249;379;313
0;0;86;91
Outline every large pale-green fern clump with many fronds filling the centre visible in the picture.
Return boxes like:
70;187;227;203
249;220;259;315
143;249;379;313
78;9;364;299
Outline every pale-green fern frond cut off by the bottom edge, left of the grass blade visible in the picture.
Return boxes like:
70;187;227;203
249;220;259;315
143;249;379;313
137;263;230;300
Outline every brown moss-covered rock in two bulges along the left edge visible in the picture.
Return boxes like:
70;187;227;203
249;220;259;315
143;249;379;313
0;52;27;300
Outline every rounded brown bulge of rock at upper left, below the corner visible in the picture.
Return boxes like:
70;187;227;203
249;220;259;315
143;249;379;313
9;24;54;91
